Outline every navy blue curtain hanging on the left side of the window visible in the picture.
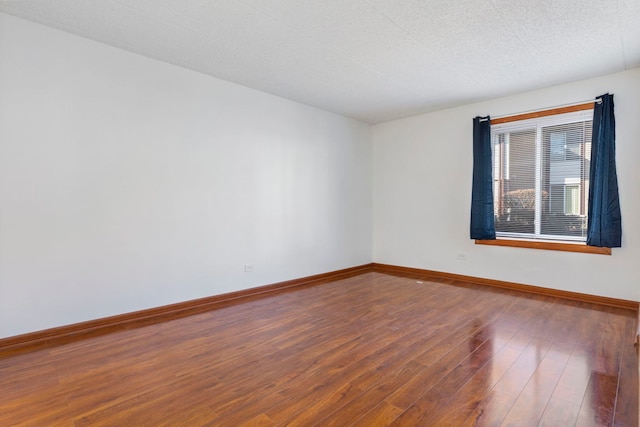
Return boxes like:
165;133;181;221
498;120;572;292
470;116;496;240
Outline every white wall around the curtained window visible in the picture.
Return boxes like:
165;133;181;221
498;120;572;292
373;69;640;301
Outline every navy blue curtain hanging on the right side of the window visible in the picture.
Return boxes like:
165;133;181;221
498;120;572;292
587;93;622;248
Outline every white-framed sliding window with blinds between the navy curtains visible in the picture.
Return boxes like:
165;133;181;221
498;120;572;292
491;110;593;243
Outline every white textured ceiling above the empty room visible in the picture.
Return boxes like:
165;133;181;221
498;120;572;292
0;0;640;123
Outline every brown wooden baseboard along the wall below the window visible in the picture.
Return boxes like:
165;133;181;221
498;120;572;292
372;263;640;311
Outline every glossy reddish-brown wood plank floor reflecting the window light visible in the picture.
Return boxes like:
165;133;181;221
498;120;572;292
0;273;638;427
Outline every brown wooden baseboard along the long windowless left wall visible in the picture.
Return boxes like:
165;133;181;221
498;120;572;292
0;264;372;357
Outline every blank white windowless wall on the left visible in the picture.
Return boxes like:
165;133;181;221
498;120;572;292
0;14;372;337
